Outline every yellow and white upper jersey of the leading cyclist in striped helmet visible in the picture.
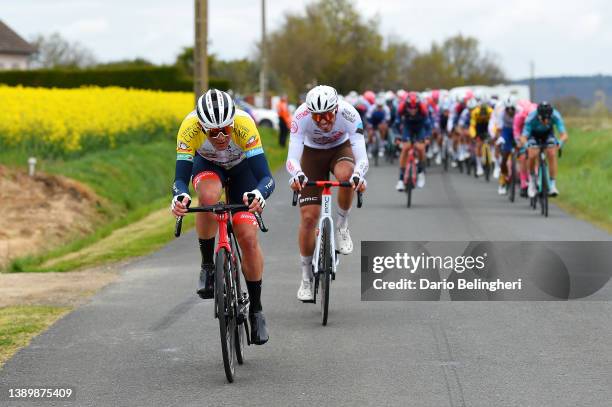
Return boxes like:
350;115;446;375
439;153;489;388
176;109;264;170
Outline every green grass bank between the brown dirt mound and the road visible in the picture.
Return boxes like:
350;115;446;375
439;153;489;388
8;129;287;272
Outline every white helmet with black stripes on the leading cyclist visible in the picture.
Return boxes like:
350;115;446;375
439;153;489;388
196;89;236;129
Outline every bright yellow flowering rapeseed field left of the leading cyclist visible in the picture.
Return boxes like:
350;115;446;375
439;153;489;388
0;85;193;155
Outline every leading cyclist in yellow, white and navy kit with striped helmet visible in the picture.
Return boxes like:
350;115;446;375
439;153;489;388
171;89;274;345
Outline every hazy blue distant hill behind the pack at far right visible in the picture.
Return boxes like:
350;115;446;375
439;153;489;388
513;75;612;108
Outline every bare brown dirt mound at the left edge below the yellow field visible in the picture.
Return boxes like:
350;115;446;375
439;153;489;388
0;166;100;269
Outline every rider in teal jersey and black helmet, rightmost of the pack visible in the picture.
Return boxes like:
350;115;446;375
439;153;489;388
522;102;569;198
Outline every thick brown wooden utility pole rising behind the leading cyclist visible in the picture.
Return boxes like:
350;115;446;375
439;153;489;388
193;0;208;101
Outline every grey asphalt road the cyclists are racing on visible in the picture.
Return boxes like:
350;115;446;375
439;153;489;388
0;161;612;407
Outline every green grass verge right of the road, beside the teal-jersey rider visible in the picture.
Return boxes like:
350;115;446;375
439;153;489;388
557;129;612;232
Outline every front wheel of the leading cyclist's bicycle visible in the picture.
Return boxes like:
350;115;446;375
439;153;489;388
215;248;238;383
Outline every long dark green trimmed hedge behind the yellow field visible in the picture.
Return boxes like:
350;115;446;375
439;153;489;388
0;66;230;92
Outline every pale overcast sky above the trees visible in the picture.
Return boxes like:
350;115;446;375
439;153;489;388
0;0;612;79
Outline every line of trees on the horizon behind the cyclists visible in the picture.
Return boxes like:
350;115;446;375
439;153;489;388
26;0;506;98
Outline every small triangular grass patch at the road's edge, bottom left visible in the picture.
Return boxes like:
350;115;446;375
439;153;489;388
0;305;71;366
